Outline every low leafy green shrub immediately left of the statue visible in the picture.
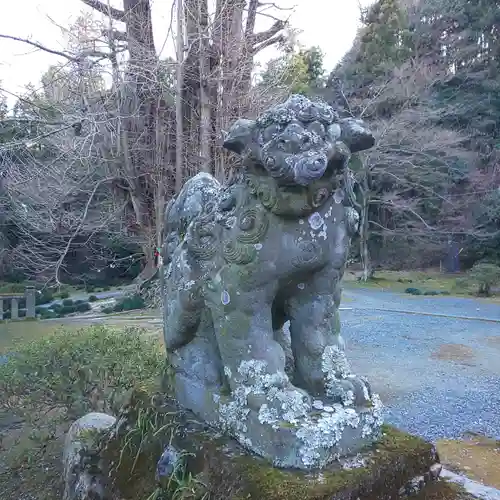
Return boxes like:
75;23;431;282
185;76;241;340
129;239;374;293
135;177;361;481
0;325;165;416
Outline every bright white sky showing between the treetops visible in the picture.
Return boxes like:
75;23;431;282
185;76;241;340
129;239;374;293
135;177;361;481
0;0;371;102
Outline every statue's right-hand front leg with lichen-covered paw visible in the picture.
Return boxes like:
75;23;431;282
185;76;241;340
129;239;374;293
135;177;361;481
289;269;370;405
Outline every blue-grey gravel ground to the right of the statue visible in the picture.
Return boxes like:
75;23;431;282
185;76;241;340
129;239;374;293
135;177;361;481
341;289;500;440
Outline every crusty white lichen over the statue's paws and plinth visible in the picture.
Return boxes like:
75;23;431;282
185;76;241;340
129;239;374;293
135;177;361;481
219;356;382;468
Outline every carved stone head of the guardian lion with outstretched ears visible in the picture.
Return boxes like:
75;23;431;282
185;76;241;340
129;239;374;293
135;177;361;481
223;95;375;186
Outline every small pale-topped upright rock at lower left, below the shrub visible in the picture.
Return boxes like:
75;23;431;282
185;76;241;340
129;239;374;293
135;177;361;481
63;413;116;500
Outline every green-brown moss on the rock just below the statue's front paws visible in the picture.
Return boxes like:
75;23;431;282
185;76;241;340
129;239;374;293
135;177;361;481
213;426;436;500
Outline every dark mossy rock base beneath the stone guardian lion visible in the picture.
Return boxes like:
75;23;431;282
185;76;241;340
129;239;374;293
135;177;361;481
99;392;452;500
